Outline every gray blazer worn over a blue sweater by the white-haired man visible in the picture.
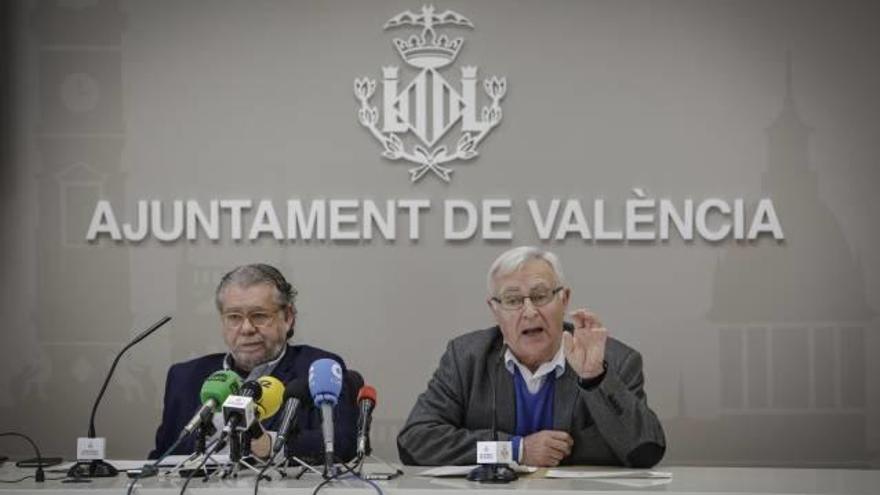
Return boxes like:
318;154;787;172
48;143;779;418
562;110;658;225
397;324;666;467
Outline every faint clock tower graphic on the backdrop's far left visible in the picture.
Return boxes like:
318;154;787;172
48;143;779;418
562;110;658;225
26;0;141;458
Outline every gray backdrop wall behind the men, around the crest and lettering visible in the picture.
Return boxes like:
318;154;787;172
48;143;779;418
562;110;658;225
0;0;880;465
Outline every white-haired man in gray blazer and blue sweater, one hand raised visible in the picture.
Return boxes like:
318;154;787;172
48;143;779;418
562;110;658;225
397;247;666;467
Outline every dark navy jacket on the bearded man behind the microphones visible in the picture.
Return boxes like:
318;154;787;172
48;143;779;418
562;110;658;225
149;345;358;460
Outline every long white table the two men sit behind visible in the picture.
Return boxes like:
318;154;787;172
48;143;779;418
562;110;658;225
0;464;880;495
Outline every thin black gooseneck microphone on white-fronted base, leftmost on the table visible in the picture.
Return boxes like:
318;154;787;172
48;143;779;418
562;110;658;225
67;316;171;478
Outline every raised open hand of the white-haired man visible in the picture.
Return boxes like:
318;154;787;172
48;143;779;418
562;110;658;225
562;309;608;380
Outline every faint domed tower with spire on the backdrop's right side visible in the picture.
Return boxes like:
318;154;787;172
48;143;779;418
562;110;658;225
704;58;877;463
